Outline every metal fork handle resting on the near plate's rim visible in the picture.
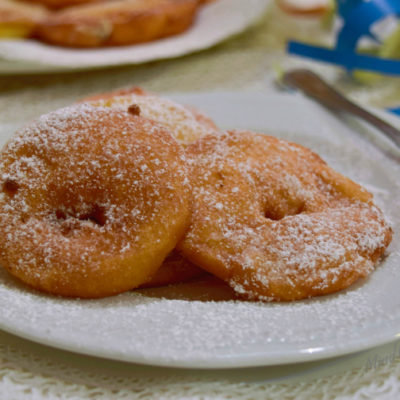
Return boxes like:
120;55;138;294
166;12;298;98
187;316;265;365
282;69;400;148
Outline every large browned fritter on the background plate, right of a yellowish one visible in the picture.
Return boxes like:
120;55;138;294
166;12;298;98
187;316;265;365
37;0;198;47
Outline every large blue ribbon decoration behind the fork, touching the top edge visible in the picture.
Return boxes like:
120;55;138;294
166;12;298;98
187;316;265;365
287;0;400;75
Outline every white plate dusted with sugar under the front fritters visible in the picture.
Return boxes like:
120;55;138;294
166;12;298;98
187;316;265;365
0;93;400;368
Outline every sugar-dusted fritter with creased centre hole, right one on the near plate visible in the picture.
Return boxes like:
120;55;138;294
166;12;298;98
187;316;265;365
178;132;392;300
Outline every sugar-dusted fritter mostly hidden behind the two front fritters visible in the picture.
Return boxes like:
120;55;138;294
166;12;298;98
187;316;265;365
82;87;218;146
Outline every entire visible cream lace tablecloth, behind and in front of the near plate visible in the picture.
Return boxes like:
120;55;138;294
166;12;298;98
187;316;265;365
0;3;400;400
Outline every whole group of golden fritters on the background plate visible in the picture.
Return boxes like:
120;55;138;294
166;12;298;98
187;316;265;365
0;0;216;48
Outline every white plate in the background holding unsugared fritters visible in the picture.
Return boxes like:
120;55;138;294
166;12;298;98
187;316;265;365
0;0;271;73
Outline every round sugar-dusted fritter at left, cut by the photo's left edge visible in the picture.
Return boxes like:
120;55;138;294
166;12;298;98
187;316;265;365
0;104;190;298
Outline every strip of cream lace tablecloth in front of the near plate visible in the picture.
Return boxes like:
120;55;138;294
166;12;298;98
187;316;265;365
0;333;400;400
